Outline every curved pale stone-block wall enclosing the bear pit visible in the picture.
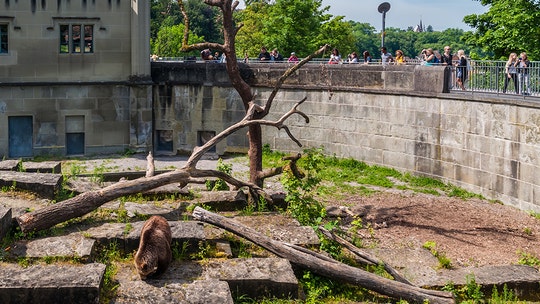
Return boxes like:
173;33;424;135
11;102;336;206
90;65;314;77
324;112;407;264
153;65;540;212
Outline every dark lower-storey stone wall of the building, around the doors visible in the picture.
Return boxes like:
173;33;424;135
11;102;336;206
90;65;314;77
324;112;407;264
0;84;152;157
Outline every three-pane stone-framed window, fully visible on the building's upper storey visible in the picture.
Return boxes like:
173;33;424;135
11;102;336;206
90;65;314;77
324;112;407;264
60;24;94;54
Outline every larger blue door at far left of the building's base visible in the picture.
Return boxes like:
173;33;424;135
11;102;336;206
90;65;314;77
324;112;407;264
8;116;34;158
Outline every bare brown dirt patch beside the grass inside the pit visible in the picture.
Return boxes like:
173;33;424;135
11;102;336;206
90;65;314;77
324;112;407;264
335;192;540;267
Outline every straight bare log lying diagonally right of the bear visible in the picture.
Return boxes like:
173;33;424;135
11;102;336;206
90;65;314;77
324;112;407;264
193;207;455;303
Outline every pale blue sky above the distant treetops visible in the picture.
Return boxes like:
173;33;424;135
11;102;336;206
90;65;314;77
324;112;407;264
322;0;488;31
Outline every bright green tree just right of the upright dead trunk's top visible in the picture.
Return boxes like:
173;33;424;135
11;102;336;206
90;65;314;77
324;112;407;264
236;0;355;57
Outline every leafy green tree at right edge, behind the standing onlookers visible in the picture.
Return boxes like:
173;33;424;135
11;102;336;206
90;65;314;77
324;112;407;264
463;0;540;59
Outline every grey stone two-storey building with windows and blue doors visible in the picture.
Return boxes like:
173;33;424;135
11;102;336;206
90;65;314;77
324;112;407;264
0;0;152;158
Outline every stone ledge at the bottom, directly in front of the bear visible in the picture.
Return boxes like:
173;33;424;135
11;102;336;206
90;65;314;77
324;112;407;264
114;258;299;303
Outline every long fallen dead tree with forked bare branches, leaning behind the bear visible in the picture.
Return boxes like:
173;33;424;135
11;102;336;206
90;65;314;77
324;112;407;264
17;99;307;233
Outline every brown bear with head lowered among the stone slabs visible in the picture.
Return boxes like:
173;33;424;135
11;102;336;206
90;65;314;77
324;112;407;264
134;215;172;280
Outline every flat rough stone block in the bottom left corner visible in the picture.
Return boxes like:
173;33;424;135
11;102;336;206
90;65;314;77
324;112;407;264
0;263;105;304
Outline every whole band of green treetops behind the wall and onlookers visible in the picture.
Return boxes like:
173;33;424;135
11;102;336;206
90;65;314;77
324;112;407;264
151;0;506;59
